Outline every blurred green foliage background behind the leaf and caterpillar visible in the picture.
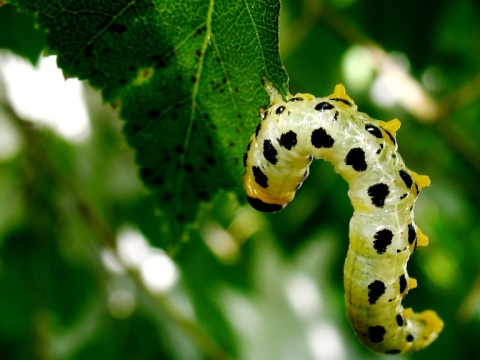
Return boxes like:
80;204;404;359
0;0;480;360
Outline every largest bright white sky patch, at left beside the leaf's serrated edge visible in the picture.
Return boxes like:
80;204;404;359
0;52;90;142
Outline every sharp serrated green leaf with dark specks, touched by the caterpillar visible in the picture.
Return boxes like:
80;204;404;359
7;0;287;245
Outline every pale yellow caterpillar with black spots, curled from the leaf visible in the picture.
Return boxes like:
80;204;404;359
243;77;443;354
